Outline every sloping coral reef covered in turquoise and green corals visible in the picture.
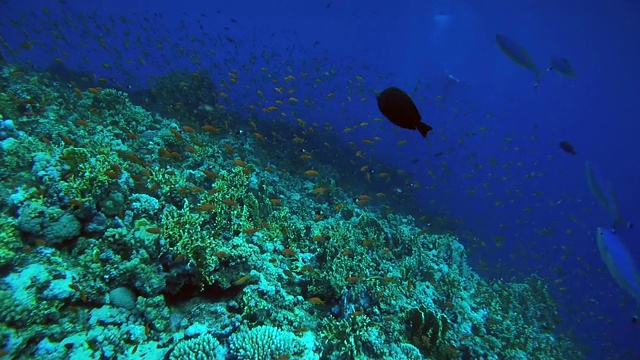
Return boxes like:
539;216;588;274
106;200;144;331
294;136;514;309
0;54;580;359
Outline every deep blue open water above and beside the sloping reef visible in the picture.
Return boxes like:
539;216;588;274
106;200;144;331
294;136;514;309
0;0;640;359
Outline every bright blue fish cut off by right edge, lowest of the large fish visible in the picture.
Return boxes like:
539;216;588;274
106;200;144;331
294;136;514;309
597;228;640;304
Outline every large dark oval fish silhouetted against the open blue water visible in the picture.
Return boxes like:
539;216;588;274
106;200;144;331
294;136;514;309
376;87;433;137
